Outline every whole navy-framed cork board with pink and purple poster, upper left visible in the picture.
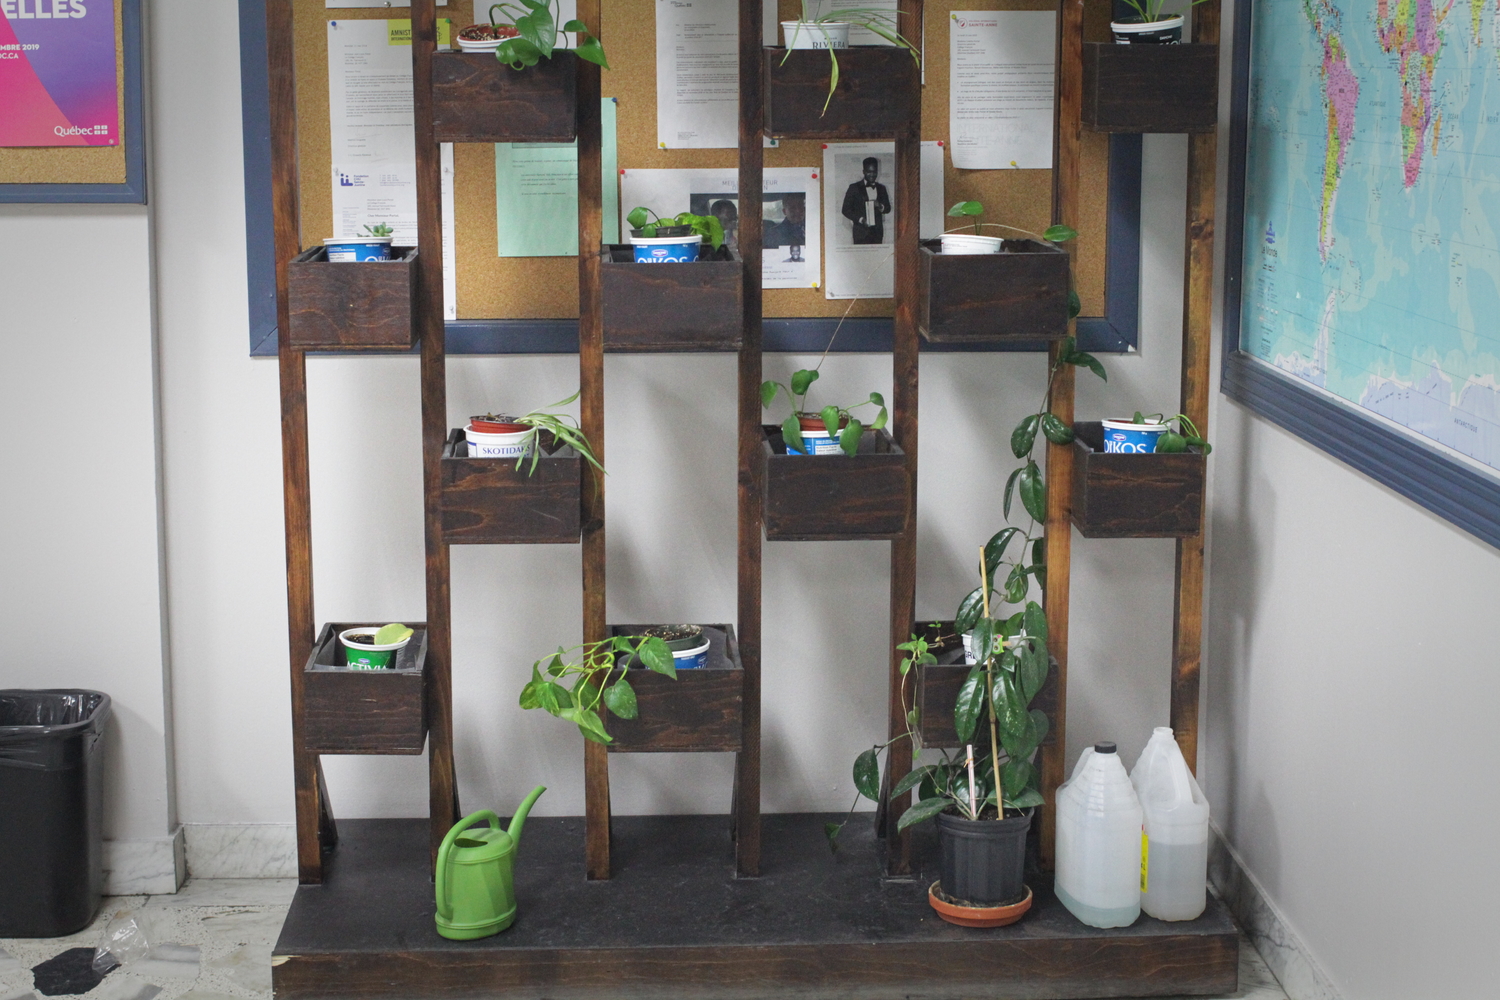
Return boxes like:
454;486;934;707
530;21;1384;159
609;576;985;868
0;0;146;204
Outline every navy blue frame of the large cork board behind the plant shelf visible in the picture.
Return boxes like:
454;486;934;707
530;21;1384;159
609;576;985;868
240;0;1142;357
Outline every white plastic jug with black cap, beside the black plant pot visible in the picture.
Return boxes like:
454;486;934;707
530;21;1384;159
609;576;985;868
1056;742;1142;927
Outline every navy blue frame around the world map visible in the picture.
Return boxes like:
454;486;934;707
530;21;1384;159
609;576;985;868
1220;0;1500;547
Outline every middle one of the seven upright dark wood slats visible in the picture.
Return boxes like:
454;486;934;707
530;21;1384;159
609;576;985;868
732;0;765;877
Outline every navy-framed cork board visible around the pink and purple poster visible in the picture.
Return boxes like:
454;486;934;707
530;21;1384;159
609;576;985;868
0;0;146;204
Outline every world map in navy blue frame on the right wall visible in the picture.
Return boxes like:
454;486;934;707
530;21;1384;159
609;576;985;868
1223;0;1500;546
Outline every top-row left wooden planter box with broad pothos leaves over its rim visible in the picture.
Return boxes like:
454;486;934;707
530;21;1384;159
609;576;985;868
432;51;578;142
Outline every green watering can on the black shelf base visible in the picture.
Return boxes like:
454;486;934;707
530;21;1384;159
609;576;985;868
435;784;546;942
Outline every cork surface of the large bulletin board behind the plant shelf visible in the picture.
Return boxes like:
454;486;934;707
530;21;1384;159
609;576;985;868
286;0;1110;319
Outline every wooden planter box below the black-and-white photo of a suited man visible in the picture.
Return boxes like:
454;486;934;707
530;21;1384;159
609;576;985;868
761;426;911;541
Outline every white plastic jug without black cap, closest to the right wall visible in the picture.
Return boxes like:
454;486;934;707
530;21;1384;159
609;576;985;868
1130;726;1209;921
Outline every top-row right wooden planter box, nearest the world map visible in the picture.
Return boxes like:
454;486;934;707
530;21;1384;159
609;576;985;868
1083;42;1218;132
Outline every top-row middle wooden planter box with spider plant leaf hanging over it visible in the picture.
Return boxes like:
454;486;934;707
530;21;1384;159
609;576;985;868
765;45;921;138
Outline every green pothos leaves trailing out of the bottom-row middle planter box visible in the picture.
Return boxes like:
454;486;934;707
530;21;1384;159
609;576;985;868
521;636;677;744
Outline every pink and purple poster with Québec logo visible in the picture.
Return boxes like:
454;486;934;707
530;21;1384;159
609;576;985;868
0;0;120;147
